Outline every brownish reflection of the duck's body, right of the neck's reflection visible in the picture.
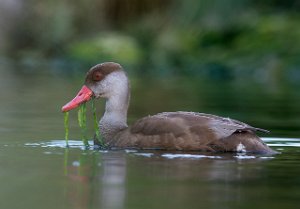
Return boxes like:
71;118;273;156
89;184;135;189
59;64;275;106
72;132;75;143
128;152;276;208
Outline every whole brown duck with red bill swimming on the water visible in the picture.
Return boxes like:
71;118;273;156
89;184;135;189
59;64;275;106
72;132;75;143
62;62;276;154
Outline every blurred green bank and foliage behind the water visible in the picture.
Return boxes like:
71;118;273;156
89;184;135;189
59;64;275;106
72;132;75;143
0;0;300;77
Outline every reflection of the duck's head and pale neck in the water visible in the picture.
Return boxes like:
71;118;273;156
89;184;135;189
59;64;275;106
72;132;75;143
64;149;126;209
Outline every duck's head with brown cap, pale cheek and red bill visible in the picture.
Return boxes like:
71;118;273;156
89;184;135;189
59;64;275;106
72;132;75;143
62;62;128;112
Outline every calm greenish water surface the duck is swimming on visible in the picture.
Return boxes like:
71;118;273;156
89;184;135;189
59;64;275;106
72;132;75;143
0;66;300;209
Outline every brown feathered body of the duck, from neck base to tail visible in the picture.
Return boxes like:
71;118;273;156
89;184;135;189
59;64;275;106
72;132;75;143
112;112;273;153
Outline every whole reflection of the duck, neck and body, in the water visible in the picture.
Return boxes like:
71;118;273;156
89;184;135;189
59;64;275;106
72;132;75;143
65;151;274;209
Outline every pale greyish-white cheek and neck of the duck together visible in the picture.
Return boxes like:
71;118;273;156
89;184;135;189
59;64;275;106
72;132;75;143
99;72;130;140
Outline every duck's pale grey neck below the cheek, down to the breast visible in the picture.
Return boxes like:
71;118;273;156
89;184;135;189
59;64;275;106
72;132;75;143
99;76;130;141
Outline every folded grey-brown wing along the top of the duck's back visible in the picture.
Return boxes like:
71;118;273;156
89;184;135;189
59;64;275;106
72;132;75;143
131;112;269;138
